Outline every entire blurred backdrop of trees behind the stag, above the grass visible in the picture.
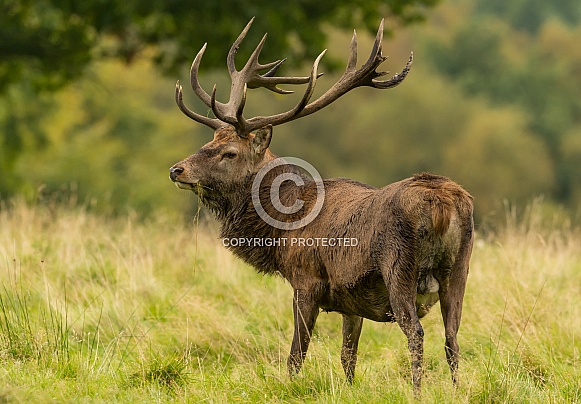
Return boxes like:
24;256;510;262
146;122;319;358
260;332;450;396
0;0;581;224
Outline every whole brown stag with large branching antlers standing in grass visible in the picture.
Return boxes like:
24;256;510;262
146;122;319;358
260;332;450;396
170;18;474;396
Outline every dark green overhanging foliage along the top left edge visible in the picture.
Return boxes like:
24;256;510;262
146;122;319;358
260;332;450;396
0;0;438;94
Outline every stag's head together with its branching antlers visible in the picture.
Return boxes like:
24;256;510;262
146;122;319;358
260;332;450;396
170;19;413;213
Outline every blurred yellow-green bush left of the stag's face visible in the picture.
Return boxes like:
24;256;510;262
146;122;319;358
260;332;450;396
14;58;200;215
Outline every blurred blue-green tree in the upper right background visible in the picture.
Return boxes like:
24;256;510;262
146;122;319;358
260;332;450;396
424;0;581;218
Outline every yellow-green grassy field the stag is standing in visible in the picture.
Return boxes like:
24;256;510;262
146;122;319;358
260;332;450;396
0;203;581;403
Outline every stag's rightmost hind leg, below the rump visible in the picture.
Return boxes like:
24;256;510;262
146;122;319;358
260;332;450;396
439;229;472;385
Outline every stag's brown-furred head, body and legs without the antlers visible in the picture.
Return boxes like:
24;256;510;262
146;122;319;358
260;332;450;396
170;127;473;391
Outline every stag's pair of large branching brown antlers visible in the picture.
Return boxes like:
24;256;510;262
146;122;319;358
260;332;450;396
176;18;413;137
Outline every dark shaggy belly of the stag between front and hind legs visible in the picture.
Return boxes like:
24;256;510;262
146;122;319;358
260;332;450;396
322;272;395;322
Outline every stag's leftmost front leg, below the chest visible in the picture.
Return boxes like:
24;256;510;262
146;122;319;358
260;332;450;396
288;289;319;377
